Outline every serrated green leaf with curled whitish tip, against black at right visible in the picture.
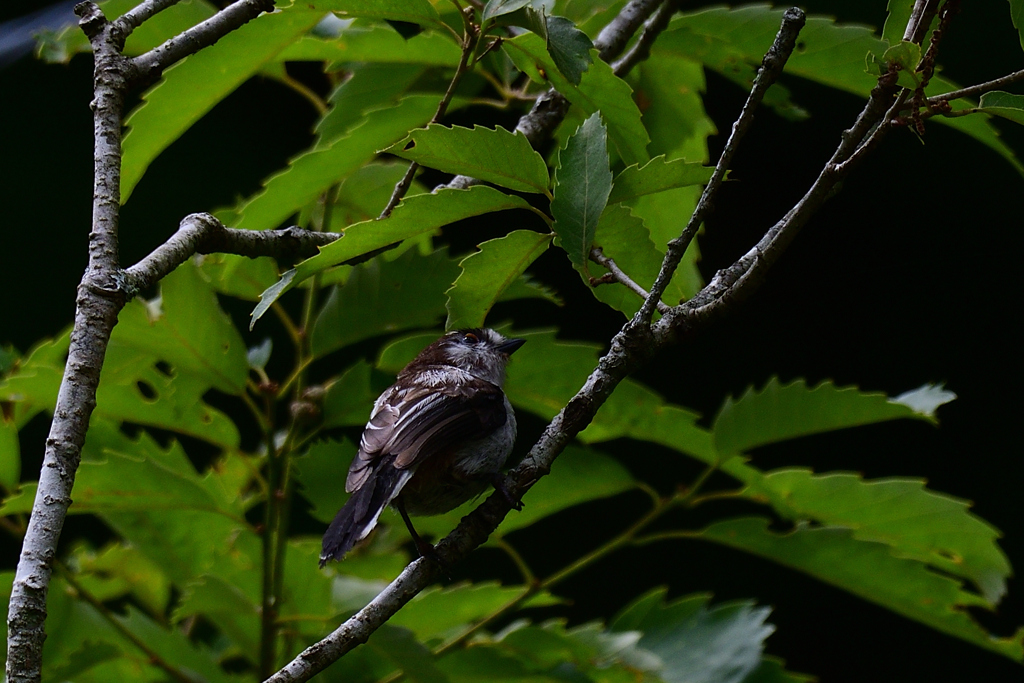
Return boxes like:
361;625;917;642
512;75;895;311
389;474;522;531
712;378;935;455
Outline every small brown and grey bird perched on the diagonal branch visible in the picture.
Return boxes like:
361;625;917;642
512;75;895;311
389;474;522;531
319;329;526;567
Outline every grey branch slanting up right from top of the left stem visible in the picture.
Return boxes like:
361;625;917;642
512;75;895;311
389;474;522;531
131;0;274;84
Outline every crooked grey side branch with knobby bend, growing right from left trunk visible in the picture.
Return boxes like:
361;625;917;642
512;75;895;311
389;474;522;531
120;213;333;296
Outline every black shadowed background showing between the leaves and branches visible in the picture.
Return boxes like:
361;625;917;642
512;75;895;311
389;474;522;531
0;0;1024;682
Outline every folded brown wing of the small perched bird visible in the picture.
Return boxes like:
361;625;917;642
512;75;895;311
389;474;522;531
345;374;508;493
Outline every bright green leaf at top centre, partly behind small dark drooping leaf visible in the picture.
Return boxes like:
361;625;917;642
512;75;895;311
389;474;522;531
502;33;650;164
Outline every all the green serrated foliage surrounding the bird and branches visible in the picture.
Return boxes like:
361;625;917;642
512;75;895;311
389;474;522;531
6;0;1024;683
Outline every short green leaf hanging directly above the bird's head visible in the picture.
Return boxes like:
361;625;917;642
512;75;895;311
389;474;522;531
444;230;551;330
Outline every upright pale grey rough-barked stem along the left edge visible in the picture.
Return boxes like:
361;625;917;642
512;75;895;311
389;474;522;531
7;2;127;683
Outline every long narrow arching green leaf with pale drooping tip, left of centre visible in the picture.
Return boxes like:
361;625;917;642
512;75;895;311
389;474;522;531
252;185;529;325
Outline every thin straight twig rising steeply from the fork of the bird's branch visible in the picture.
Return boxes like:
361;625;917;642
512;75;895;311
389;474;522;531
637;7;807;325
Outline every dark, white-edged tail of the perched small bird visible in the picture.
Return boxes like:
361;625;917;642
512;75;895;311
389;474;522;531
321;456;413;567
